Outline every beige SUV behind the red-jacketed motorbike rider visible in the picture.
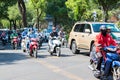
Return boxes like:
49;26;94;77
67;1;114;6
68;22;120;54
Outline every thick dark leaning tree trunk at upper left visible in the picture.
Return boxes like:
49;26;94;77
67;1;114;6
18;0;27;27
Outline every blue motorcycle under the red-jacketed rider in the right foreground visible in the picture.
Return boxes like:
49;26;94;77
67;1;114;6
88;46;120;80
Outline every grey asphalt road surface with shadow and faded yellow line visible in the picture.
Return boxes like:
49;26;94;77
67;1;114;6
0;43;97;80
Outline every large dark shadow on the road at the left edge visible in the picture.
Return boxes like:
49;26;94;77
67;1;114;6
0;52;28;65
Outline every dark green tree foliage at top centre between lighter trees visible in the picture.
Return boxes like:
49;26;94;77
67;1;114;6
46;0;68;26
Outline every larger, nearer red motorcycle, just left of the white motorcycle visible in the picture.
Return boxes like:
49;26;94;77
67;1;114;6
29;38;38;58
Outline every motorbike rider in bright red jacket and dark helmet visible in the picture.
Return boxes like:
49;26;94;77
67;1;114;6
95;25;117;78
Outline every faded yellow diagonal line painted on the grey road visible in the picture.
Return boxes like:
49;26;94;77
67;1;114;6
36;59;83;80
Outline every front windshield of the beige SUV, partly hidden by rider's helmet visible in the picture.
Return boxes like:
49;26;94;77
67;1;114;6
92;23;120;32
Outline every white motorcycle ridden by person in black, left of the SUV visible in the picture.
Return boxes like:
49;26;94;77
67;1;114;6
48;37;61;57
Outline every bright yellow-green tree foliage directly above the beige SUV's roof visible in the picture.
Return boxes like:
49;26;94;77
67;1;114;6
66;0;88;21
